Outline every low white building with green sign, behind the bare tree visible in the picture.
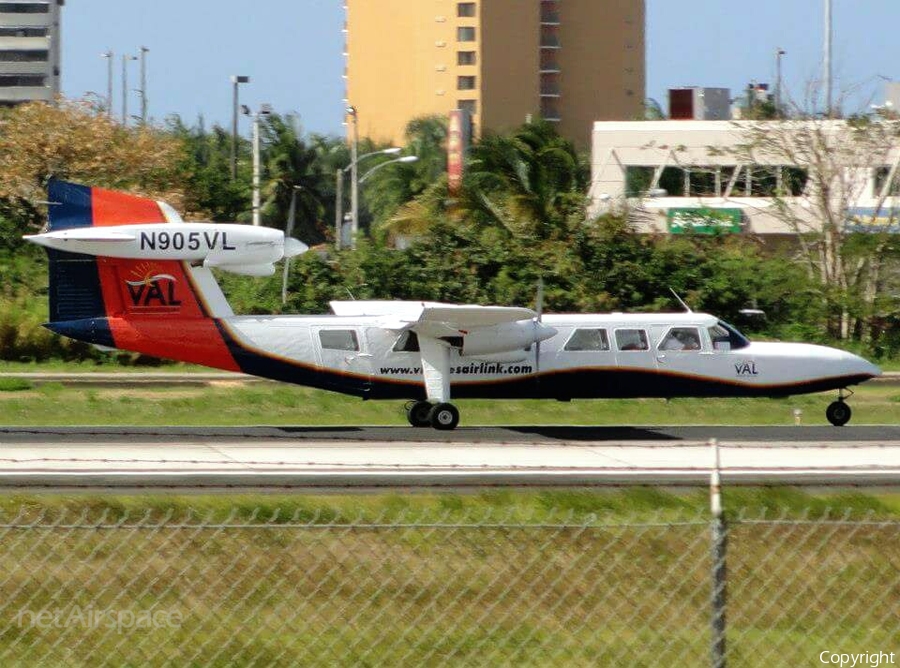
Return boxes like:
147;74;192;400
589;119;900;238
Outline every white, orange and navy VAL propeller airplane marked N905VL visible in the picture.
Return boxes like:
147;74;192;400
26;180;881;430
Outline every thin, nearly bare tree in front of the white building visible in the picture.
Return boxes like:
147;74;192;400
734;115;900;342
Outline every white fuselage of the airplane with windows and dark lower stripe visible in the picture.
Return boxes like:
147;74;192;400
216;313;880;399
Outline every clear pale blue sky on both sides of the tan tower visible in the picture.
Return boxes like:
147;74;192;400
62;0;900;134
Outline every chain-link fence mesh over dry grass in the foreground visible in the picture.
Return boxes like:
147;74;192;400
0;508;900;668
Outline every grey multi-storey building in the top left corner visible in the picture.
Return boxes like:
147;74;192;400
0;0;65;106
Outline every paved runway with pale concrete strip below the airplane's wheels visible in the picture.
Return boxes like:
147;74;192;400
0;426;900;490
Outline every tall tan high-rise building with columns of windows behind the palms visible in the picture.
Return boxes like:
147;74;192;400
345;0;645;147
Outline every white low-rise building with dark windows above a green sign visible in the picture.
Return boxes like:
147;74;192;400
589;120;900;234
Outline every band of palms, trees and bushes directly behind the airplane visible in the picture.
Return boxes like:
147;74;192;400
0;103;900;365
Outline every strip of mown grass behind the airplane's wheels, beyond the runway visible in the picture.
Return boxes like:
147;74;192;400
0;380;888;427
